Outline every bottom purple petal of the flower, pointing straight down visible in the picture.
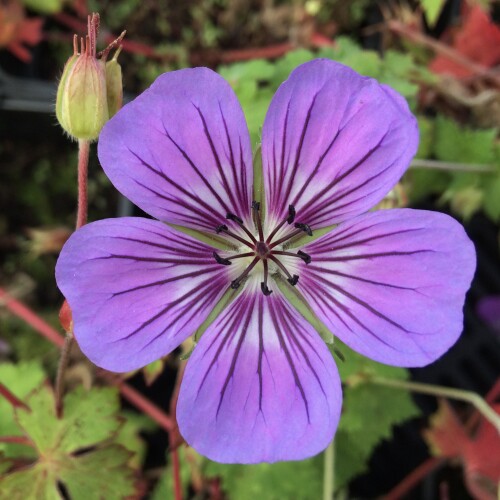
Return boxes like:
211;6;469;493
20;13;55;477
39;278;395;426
177;285;342;463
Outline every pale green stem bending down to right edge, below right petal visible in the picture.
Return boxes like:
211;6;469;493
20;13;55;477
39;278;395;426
368;377;500;432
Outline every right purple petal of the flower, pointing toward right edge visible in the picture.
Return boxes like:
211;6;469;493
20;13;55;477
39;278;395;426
299;209;476;366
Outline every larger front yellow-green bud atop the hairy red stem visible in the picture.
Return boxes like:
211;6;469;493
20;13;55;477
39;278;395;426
56;31;108;141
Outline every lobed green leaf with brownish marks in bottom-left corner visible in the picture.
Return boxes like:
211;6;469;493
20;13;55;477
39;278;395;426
0;385;141;500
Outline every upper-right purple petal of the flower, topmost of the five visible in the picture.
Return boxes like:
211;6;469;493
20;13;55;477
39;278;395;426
262;59;418;229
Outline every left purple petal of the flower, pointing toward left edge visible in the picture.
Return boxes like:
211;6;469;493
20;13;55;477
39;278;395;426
56;217;229;372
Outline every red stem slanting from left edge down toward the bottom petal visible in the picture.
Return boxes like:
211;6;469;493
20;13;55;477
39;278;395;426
0;288;175;432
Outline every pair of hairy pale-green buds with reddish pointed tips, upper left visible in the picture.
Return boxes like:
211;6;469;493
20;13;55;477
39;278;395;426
56;14;125;141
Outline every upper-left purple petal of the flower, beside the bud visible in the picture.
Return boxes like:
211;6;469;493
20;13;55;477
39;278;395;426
99;68;253;231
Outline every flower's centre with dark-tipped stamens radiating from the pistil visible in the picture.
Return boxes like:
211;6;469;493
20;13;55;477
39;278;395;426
213;201;312;295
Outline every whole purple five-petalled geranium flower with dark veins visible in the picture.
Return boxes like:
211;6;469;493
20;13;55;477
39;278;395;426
56;60;475;463
